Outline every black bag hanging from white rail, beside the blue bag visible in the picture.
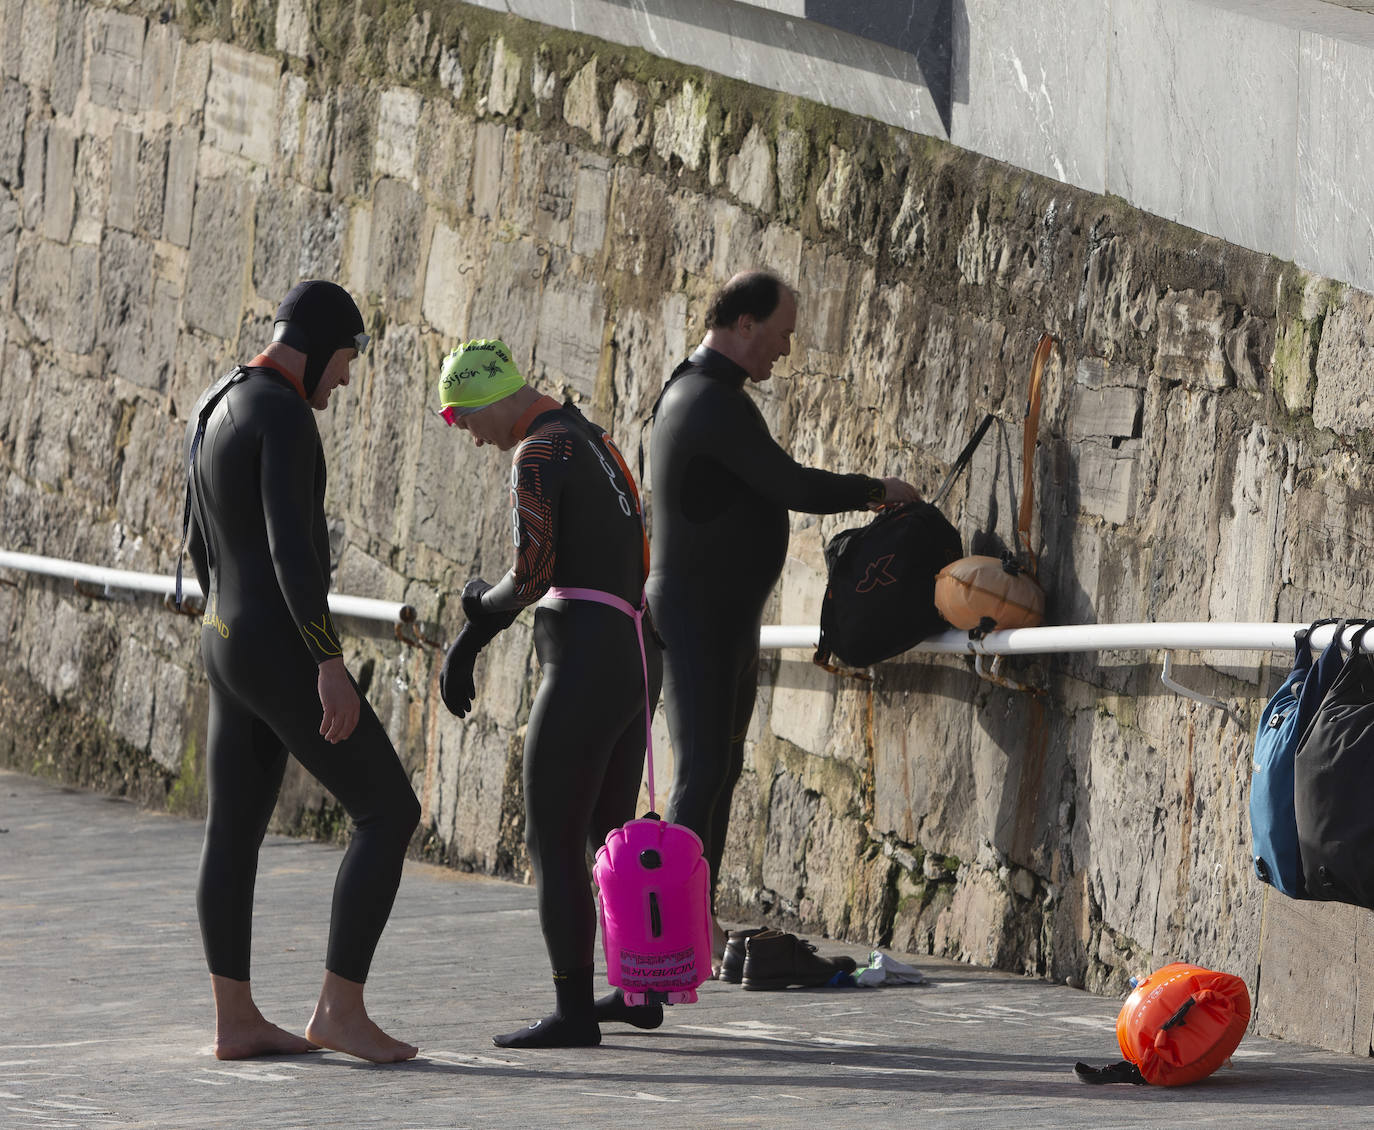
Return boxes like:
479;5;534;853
1293;624;1374;910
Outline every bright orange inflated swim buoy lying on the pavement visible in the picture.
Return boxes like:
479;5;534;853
1117;962;1250;1087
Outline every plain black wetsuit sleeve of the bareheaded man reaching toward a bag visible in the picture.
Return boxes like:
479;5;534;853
703;389;882;514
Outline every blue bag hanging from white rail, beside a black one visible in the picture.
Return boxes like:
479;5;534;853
1250;620;1348;899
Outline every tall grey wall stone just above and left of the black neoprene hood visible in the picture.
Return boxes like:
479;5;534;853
181;179;253;338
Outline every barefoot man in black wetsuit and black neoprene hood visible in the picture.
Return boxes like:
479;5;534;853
187;282;419;1063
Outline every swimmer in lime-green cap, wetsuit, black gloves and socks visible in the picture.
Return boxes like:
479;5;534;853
440;341;664;1048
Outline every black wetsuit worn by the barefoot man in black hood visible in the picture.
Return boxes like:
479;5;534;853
188;368;419;982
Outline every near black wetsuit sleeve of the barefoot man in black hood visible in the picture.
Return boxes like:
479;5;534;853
261;403;344;663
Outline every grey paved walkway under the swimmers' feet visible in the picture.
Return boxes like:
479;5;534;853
0;771;1374;1130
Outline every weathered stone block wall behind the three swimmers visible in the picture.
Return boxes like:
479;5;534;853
0;0;1374;1053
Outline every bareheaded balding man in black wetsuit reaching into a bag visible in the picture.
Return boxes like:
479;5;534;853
649;271;919;958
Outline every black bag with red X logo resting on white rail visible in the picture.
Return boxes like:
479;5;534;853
816;502;963;667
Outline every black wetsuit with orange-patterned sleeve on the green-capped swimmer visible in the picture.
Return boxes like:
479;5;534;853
482;397;662;972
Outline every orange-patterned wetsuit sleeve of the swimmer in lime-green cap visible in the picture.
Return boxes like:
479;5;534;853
482;423;572;612
